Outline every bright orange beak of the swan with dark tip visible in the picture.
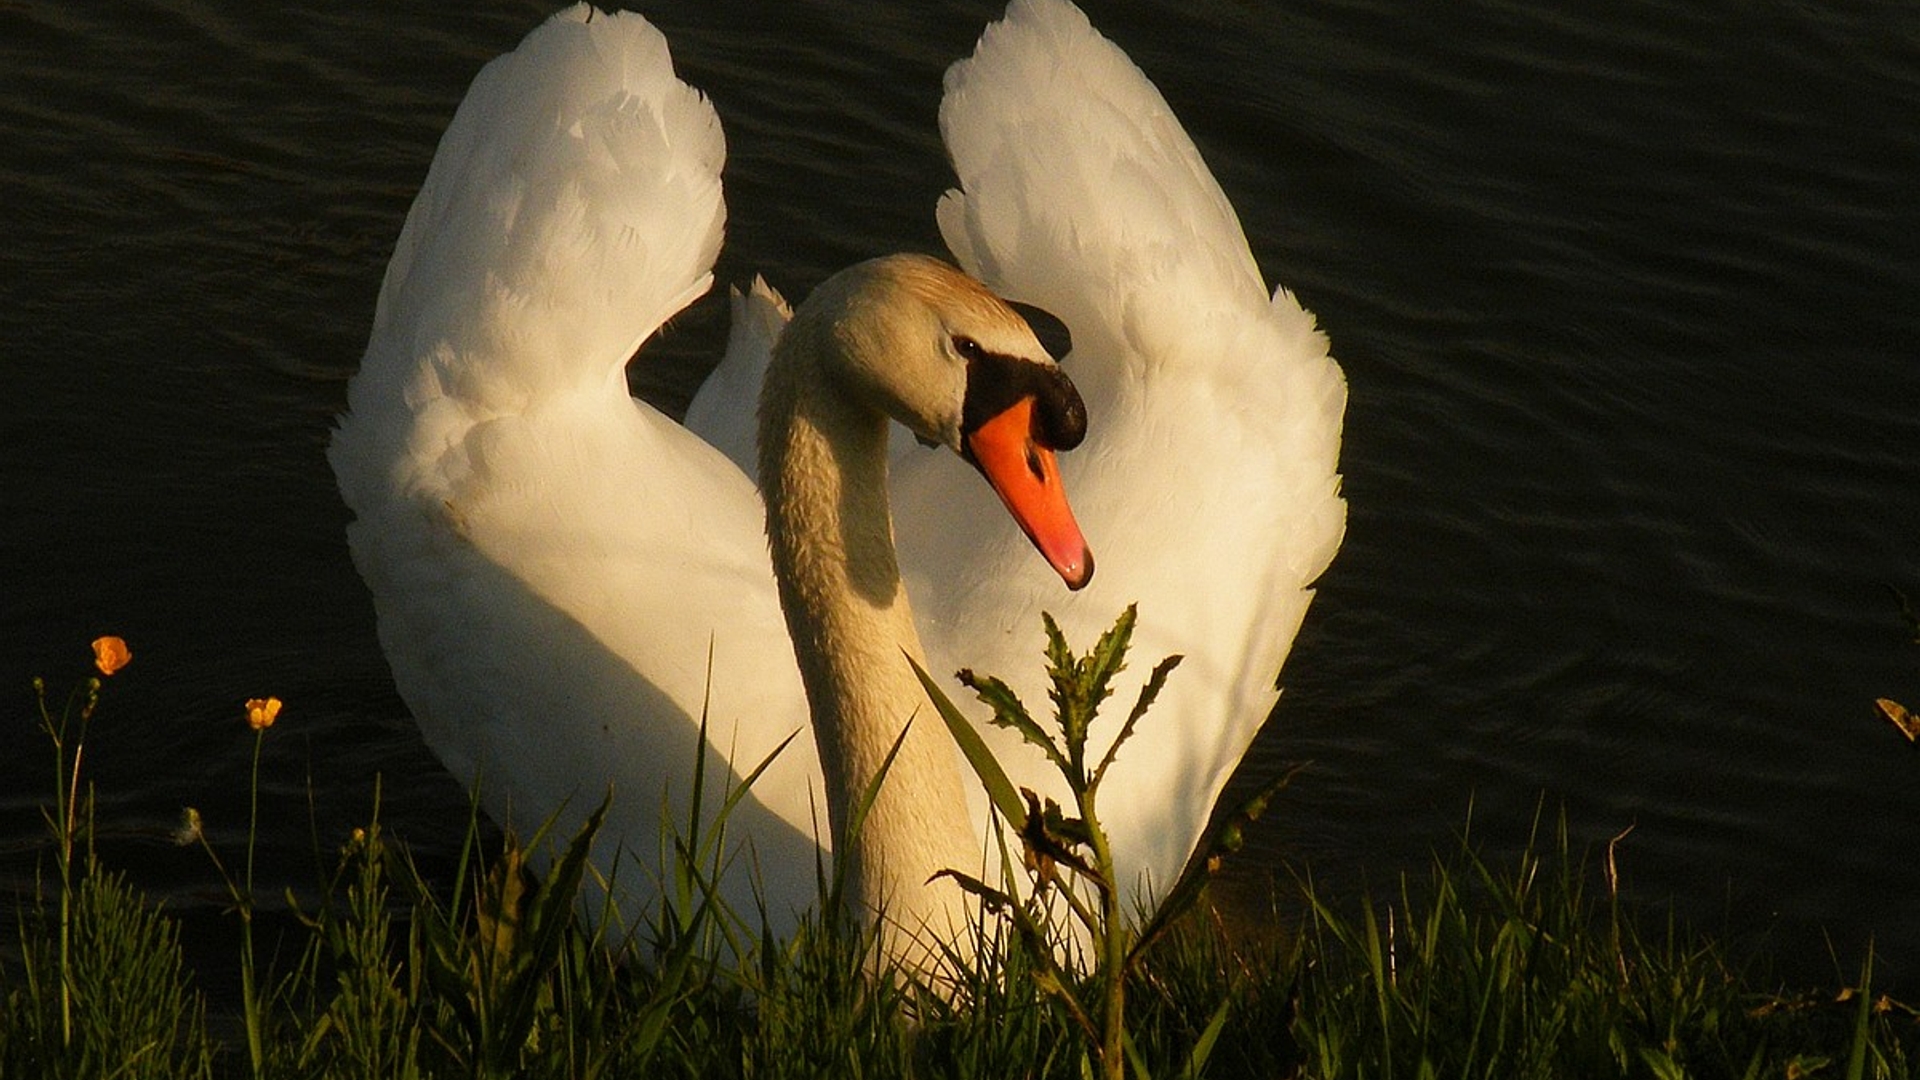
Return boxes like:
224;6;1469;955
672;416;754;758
962;398;1092;590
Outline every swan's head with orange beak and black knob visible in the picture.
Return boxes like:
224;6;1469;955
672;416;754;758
787;256;1092;590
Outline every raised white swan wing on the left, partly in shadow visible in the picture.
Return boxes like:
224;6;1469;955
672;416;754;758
328;4;818;919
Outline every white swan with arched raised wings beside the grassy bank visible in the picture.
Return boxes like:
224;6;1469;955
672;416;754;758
328;0;1346;957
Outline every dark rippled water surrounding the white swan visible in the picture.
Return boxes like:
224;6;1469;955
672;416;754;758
0;0;1920;986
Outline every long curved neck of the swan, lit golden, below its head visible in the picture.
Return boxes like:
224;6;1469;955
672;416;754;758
760;307;981;957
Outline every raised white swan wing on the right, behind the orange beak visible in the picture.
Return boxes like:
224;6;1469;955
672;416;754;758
895;0;1346;899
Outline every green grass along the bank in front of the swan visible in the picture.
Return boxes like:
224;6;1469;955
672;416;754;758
0;634;1920;1080
